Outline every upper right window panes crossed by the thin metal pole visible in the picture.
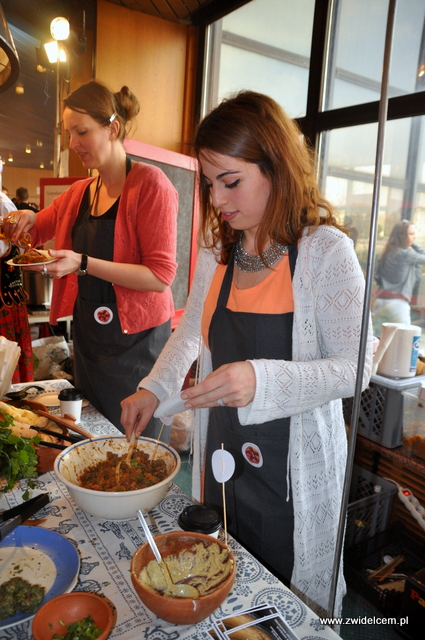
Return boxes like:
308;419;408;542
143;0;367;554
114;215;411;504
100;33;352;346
323;0;425;110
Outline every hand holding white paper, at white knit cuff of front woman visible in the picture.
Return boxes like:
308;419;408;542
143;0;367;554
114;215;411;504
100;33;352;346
181;362;256;409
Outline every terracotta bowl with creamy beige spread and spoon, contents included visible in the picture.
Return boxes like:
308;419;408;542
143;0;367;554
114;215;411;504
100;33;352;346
130;531;235;625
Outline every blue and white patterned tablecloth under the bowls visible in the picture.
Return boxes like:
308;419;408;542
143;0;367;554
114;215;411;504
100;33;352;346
0;381;338;640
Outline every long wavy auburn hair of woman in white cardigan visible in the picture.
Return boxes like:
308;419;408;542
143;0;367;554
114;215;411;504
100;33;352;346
194;91;343;264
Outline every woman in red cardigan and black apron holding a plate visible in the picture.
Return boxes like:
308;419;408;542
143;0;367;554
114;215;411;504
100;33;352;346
3;81;178;436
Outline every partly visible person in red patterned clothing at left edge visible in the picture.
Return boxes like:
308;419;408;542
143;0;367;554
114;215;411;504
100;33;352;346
0;192;34;384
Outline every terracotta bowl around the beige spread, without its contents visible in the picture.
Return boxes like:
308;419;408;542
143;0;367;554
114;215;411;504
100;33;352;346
130;531;236;625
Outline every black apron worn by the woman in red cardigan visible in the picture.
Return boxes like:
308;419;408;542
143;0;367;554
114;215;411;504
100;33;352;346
72;157;171;442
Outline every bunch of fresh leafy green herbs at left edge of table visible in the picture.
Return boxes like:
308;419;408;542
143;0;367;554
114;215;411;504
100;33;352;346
0;412;41;500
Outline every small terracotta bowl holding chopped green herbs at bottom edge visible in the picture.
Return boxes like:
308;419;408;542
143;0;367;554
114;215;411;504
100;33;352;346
32;591;116;640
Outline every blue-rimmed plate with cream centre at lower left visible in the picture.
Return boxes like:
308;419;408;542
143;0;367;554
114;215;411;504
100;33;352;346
0;525;80;631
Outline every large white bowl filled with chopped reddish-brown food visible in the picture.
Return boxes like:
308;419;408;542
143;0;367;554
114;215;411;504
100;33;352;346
54;435;181;520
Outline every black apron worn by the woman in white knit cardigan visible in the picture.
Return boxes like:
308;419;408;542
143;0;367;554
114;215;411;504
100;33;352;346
204;245;297;583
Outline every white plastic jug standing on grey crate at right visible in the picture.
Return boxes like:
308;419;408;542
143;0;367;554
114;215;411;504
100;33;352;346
374;322;422;378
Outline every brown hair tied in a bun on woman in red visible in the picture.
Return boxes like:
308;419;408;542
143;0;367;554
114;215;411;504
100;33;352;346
63;80;140;142
